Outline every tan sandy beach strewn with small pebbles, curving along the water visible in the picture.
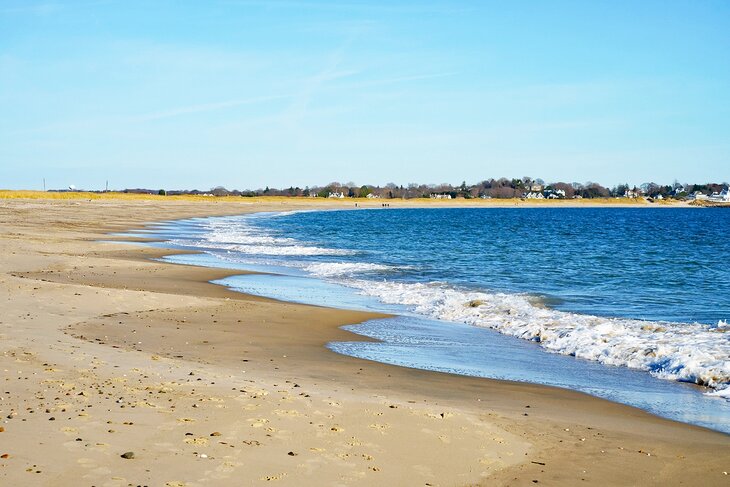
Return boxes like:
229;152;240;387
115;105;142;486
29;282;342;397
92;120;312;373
0;198;730;486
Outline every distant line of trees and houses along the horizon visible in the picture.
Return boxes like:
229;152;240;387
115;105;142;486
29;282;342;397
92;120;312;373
124;177;728;199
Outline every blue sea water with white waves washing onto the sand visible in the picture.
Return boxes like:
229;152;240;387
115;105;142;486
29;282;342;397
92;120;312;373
131;208;730;432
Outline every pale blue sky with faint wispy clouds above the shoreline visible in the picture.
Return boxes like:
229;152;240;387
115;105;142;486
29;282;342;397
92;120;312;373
0;0;730;189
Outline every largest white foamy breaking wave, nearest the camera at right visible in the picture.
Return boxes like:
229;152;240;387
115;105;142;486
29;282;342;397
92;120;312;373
348;280;730;398
